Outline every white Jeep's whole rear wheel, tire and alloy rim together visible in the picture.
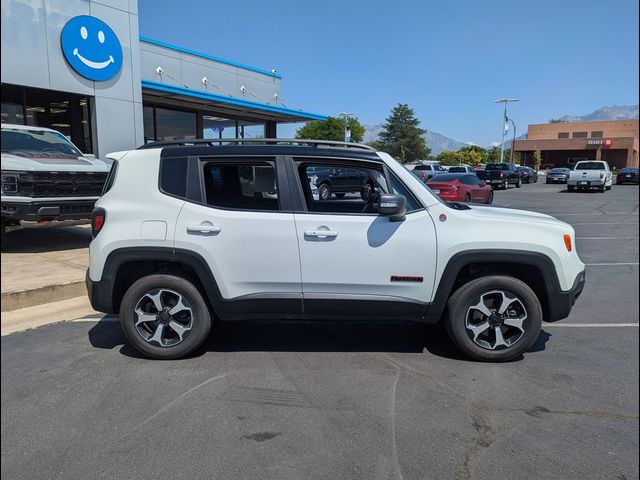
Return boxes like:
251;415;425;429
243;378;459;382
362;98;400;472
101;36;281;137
120;275;211;359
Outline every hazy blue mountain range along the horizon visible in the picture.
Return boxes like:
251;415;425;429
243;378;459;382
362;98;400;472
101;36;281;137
363;105;638;155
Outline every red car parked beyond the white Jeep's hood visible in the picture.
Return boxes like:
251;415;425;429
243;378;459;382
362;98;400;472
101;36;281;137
427;173;493;203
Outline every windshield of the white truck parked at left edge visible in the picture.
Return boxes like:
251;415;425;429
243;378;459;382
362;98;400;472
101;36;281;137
2;128;82;157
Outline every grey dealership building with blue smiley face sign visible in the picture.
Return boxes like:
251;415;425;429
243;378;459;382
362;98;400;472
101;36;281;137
0;0;326;155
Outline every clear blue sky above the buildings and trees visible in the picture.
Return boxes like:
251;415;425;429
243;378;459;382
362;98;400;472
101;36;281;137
139;0;638;145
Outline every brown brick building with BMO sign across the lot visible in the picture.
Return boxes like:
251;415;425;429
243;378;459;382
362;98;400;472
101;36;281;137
514;120;638;168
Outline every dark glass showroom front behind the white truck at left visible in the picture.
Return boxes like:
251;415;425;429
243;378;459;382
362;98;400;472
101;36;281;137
1;83;93;153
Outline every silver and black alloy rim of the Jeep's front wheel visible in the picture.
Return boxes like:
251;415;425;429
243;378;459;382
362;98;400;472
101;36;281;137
465;290;527;350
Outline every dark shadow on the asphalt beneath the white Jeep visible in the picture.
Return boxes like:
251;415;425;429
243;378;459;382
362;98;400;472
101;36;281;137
88;318;551;362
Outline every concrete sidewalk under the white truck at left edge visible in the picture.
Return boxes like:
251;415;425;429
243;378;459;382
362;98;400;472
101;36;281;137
1;224;91;312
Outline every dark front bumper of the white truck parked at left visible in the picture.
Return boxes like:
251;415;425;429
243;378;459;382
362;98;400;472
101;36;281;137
0;198;97;221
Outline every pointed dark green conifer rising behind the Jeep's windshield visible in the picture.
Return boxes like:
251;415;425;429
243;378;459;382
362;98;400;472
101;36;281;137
375;103;431;163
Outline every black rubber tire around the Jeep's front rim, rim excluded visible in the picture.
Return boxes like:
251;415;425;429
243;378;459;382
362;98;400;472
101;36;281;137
444;275;542;362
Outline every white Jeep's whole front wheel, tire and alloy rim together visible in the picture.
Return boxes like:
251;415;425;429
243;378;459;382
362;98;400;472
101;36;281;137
445;275;542;362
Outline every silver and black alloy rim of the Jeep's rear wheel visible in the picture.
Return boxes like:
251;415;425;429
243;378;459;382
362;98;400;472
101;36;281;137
134;288;193;347
